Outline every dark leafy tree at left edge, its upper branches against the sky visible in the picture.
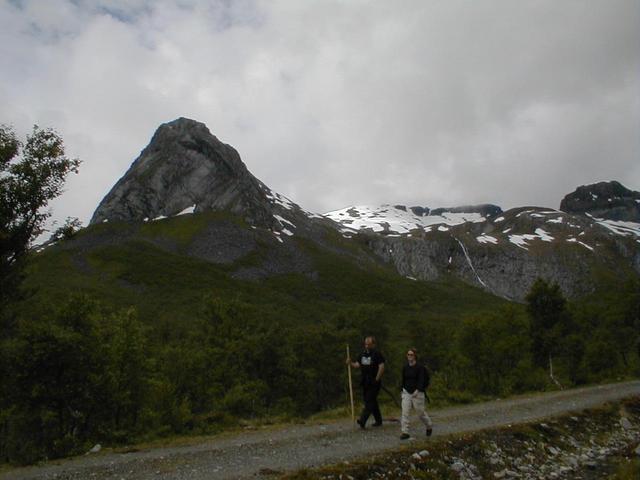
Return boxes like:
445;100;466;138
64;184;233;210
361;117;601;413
0;125;80;311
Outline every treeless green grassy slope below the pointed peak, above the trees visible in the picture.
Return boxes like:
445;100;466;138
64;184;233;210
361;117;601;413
26;214;505;332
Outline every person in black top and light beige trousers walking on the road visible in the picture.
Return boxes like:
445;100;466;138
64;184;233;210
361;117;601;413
400;348;433;440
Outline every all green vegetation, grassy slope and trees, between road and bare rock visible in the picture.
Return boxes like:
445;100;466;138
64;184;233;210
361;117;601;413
0;215;640;463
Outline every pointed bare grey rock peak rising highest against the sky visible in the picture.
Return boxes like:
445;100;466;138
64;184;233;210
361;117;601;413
91;117;273;225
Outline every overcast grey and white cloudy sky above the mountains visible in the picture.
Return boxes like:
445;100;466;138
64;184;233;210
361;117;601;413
0;0;640;232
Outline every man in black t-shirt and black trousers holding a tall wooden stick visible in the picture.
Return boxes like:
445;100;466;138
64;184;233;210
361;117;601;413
347;337;384;428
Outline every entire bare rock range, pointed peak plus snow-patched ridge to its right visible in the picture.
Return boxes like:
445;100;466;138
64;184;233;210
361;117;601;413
91;118;640;301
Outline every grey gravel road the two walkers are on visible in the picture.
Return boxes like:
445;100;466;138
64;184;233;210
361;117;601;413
0;381;640;480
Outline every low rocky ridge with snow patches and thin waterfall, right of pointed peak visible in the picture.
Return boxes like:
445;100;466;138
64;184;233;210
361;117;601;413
326;191;640;301
